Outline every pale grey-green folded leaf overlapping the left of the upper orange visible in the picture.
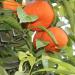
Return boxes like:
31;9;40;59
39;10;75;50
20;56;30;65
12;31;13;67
17;7;38;23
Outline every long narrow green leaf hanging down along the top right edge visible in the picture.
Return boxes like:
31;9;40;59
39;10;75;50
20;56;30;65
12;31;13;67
62;0;75;33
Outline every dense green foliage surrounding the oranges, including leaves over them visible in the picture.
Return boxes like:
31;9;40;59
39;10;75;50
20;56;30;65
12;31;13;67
0;0;75;75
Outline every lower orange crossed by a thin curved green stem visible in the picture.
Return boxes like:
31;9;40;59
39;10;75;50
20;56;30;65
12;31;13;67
33;27;68;52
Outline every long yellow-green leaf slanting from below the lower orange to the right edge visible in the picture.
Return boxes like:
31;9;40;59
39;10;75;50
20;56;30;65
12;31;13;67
44;56;75;74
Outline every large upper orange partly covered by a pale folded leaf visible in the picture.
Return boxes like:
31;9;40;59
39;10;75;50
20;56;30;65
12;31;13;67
24;0;54;31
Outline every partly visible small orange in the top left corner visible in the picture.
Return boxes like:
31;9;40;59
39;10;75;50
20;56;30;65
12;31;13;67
3;0;21;11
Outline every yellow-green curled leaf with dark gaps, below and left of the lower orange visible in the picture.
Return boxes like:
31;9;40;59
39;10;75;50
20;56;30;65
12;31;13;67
18;51;36;70
